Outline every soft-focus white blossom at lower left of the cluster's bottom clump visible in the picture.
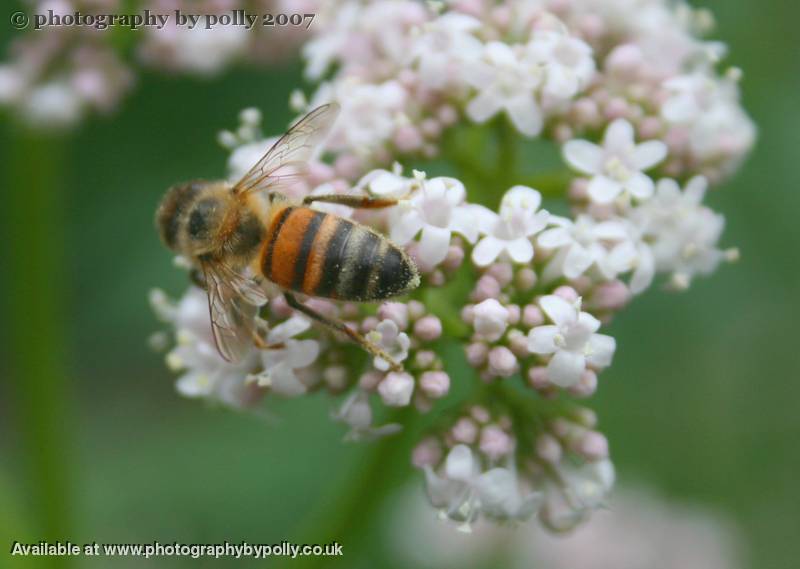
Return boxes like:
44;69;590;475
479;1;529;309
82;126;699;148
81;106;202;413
424;444;541;531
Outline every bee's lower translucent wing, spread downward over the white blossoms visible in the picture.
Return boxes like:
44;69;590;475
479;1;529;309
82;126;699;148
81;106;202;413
201;261;267;362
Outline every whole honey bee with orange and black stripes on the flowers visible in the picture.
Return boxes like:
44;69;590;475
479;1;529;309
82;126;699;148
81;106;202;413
156;104;419;370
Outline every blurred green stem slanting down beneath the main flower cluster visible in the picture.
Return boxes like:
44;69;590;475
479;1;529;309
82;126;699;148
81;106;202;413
292;406;417;569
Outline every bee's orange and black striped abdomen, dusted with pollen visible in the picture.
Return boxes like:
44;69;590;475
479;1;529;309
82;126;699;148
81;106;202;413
261;206;419;301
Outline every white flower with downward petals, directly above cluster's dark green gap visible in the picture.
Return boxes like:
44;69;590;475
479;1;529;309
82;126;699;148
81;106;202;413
465;41;543;136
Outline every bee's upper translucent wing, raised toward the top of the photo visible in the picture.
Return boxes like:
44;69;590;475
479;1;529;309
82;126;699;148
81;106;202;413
233;103;339;193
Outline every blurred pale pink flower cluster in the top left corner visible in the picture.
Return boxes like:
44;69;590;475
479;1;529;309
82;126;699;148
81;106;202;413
0;0;316;130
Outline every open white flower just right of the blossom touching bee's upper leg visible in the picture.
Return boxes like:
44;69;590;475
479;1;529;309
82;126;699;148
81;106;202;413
472;186;550;267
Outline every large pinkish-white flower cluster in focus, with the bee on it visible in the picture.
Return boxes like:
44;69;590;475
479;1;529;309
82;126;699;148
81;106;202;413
148;0;754;531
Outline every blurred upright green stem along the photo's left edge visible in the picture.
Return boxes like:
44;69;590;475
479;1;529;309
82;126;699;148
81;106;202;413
3;131;75;567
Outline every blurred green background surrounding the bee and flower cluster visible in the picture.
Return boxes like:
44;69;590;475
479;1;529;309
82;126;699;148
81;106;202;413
0;0;800;569
